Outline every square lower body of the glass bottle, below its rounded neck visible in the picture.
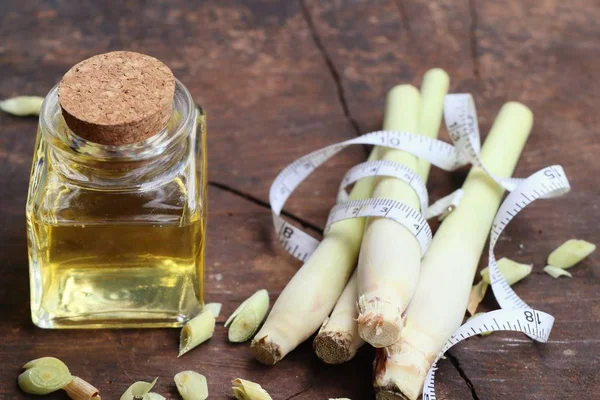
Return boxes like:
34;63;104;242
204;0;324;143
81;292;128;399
27;126;206;328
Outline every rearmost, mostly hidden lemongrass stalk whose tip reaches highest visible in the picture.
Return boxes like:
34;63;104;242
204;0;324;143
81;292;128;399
313;68;450;364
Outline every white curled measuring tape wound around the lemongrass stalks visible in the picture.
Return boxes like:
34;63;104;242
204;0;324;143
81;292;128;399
269;94;570;400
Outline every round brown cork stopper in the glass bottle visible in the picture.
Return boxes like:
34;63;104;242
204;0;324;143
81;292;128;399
58;51;175;146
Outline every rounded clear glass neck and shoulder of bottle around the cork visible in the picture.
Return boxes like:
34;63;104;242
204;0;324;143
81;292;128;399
40;81;201;191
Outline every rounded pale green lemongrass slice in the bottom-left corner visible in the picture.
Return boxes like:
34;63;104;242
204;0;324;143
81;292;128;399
18;357;73;394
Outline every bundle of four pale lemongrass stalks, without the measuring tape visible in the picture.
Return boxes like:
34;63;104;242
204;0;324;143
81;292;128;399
252;69;532;399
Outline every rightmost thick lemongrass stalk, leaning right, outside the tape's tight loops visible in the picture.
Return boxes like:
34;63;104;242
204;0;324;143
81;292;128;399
374;102;533;400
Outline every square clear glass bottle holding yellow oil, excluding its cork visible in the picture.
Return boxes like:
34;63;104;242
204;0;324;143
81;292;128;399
26;68;206;328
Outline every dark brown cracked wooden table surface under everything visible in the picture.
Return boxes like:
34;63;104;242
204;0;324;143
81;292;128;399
0;0;600;400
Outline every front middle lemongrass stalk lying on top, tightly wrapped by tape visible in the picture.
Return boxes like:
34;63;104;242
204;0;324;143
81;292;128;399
358;85;421;347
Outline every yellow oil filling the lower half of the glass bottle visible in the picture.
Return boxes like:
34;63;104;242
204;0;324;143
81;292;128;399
32;219;203;328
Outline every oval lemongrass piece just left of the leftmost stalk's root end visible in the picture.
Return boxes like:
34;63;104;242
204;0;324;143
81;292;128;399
225;289;269;343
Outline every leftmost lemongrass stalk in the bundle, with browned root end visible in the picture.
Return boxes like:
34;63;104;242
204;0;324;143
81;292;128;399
252;99;395;365
